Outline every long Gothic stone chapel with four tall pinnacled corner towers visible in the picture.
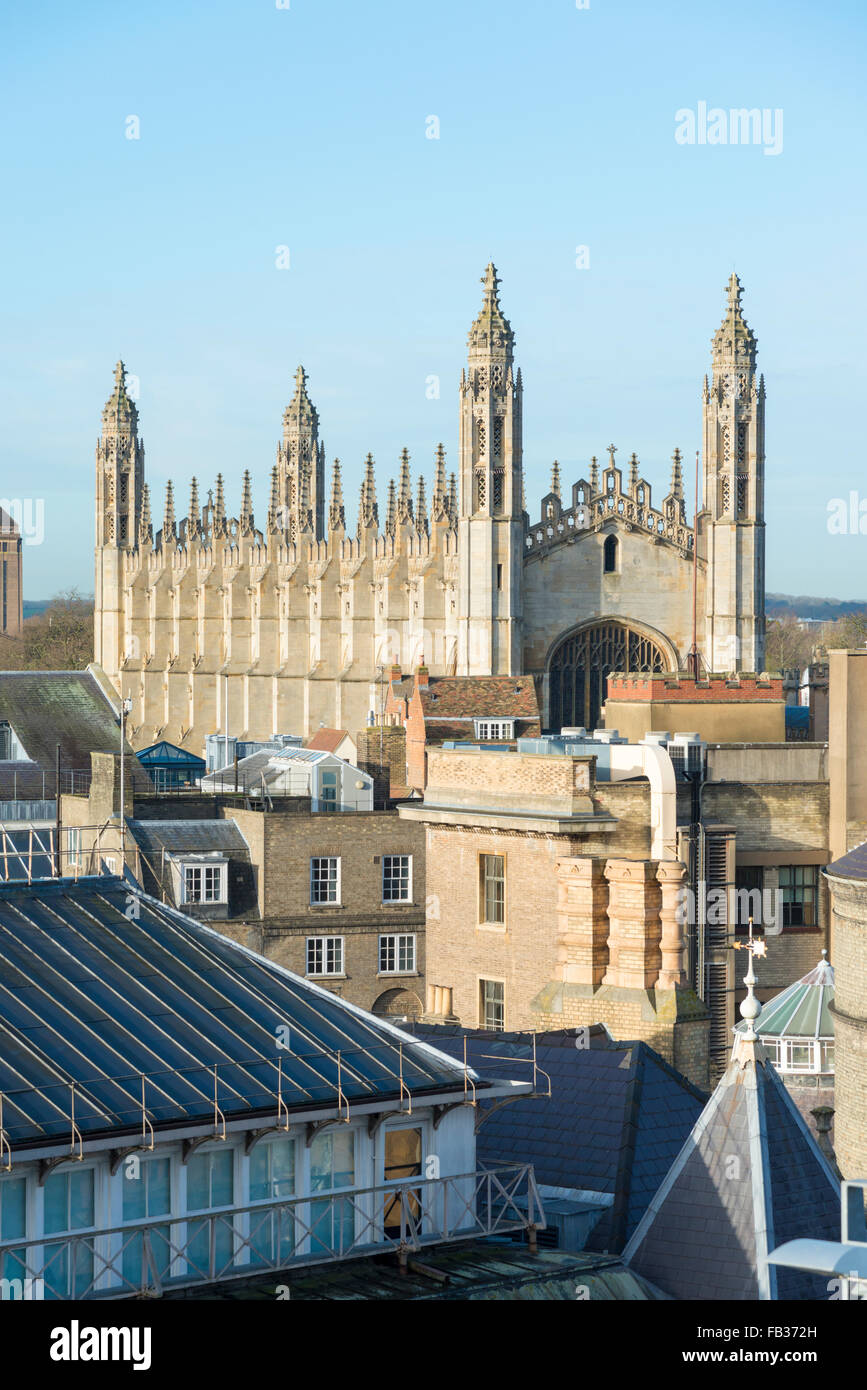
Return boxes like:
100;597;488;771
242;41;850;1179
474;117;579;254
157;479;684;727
94;264;764;751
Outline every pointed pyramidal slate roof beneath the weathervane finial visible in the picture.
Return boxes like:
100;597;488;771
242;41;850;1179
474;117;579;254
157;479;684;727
624;1020;839;1301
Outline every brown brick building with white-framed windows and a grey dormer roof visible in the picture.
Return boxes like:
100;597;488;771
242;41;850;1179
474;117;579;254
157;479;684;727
61;753;425;1016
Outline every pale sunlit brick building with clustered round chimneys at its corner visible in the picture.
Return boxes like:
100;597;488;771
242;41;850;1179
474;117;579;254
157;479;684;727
400;749;709;1086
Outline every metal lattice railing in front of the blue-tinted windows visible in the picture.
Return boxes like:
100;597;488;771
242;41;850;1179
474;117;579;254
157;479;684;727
0;1163;545;1300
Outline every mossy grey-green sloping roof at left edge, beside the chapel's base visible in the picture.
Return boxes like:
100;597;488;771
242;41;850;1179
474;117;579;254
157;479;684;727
0;671;153;796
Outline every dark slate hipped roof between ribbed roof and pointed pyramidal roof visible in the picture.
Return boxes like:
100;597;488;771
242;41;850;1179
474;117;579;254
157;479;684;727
408;1023;707;1251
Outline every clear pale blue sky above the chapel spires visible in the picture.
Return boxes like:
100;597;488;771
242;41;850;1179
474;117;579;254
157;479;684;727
0;0;867;599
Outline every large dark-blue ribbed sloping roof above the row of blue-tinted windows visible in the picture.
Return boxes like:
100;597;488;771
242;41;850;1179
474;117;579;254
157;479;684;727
0;877;497;1152
